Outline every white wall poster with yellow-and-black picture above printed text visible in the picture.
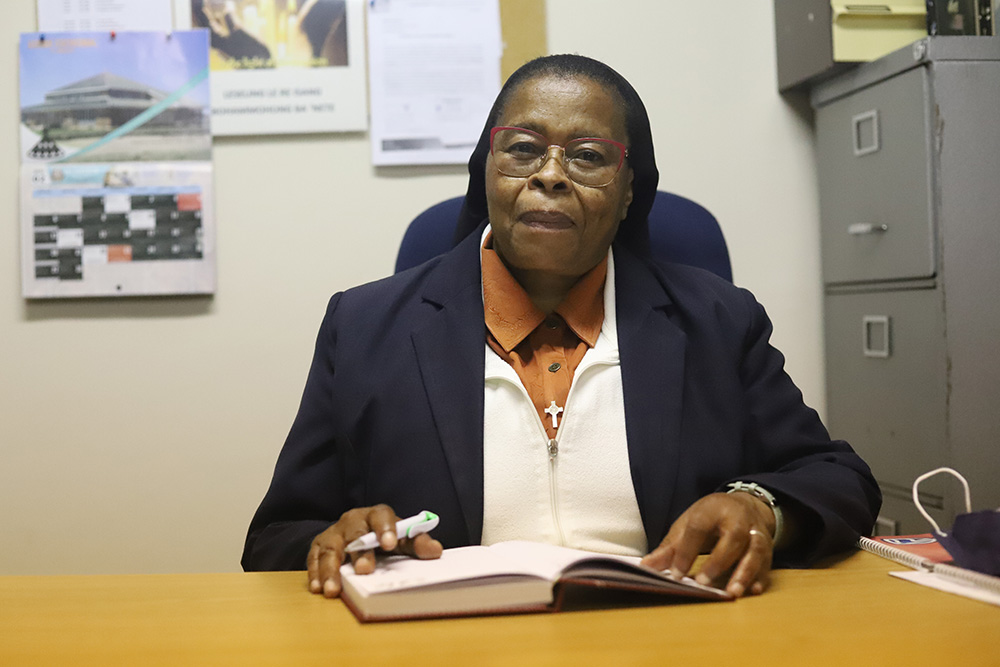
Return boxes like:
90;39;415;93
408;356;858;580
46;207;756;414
175;0;368;135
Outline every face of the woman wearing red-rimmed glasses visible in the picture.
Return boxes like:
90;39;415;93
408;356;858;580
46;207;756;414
486;75;632;277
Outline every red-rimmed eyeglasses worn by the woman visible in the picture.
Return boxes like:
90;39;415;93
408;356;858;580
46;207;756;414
490;127;628;188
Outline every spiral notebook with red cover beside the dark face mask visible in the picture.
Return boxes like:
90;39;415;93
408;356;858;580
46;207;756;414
858;533;1000;606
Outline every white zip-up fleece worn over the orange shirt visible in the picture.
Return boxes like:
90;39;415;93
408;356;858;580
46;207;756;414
482;250;646;556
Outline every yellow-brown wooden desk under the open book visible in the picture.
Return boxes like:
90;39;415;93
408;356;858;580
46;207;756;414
0;553;1000;667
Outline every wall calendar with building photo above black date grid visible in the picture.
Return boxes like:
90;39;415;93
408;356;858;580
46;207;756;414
19;30;215;298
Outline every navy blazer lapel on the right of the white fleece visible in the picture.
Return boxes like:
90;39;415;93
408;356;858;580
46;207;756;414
615;246;686;550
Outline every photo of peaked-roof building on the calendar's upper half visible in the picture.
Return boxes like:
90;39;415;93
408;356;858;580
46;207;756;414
20;31;212;163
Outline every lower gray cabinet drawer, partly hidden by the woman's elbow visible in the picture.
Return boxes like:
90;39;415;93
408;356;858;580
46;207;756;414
825;289;948;490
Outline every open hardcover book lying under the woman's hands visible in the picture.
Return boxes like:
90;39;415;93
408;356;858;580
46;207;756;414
340;542;732;621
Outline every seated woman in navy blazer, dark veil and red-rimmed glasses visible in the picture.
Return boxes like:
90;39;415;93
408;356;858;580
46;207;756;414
243;56;880;597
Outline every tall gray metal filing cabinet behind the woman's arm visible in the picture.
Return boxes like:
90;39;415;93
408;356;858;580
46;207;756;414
811;37;1000;534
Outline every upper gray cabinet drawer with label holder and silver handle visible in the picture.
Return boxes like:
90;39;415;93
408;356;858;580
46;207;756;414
816;67;935;283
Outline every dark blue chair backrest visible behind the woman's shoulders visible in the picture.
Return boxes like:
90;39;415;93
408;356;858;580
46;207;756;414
396;190;733;282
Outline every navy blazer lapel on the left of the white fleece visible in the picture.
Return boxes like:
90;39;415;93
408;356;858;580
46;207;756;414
411;234;486;544
